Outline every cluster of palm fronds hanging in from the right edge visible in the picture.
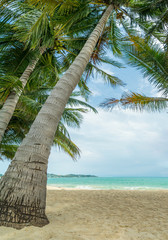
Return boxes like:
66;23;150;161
101;0;168;111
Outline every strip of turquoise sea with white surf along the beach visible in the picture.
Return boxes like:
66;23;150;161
47;177;168;190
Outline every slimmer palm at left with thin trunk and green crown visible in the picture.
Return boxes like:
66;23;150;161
0;1;95;142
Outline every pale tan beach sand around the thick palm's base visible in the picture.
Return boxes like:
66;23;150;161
0;190;168;240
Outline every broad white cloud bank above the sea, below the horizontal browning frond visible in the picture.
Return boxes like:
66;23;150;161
49;110;168;176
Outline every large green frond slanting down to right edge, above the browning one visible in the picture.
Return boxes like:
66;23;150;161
123;20;168;95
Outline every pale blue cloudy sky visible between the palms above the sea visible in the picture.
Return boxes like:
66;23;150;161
0;57;168;177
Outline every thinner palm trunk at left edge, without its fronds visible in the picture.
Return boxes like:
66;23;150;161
0;49;44;143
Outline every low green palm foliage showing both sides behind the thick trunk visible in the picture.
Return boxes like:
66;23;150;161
0;90;97;160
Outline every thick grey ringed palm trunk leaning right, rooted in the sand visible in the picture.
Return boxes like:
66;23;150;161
0;5;112;228
